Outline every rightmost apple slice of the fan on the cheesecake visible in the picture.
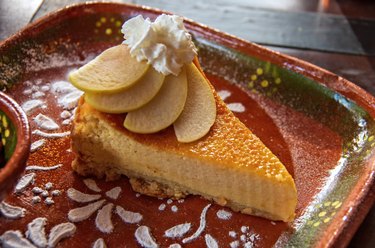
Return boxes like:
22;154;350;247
173;63;216;143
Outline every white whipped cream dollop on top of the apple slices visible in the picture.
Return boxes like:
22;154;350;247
121;14;197;76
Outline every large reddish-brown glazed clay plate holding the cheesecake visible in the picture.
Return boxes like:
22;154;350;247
0;3;375;247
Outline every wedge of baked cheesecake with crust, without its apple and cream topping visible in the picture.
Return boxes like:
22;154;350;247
72;73;297;222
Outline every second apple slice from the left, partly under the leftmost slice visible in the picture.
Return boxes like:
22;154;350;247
85;68;165;114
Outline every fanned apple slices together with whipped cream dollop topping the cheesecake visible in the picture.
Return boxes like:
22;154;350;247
69;14;216;143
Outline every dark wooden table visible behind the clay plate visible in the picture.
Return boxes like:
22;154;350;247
0;0;375;248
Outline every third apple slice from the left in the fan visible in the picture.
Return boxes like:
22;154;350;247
124;69;188;133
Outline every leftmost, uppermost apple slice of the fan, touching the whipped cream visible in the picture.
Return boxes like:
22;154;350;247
69;45;150;93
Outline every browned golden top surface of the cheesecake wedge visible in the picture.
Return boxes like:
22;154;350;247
80;87;293;183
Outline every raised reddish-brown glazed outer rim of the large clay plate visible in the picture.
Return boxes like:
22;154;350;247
0;1;375;247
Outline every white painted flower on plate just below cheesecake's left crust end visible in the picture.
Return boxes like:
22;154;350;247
67;179;143;233
